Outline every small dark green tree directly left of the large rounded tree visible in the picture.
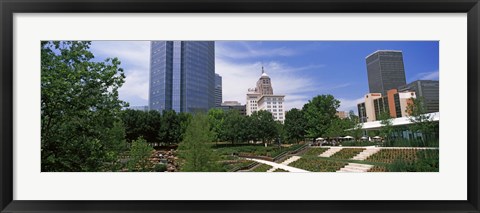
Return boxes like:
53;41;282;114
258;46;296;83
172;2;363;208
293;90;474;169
285;108;306;143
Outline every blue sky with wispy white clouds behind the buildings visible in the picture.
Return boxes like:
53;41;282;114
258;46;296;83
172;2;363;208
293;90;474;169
91;41;439;112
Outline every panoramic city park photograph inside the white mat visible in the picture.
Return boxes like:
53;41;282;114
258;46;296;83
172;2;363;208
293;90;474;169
41;40;440;175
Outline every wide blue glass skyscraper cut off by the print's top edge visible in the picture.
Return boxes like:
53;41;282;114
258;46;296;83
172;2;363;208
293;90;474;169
149;41;215;112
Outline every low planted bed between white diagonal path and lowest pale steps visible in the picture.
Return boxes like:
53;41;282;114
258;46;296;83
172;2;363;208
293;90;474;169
289;157;348;172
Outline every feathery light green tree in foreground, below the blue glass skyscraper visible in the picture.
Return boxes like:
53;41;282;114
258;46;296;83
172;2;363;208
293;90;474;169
178;113;221;172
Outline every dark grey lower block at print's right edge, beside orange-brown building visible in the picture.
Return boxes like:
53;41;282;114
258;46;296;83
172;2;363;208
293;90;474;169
398;80;440;113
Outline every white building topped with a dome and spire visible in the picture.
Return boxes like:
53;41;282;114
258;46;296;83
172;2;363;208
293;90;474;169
246;66;285;123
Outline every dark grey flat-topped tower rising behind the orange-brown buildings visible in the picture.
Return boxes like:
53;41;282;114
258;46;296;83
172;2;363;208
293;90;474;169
366;50;407;95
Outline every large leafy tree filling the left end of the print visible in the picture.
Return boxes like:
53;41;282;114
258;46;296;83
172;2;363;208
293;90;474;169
41;41;127;171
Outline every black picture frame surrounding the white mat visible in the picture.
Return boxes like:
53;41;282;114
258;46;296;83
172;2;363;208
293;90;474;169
0;0;480;213
